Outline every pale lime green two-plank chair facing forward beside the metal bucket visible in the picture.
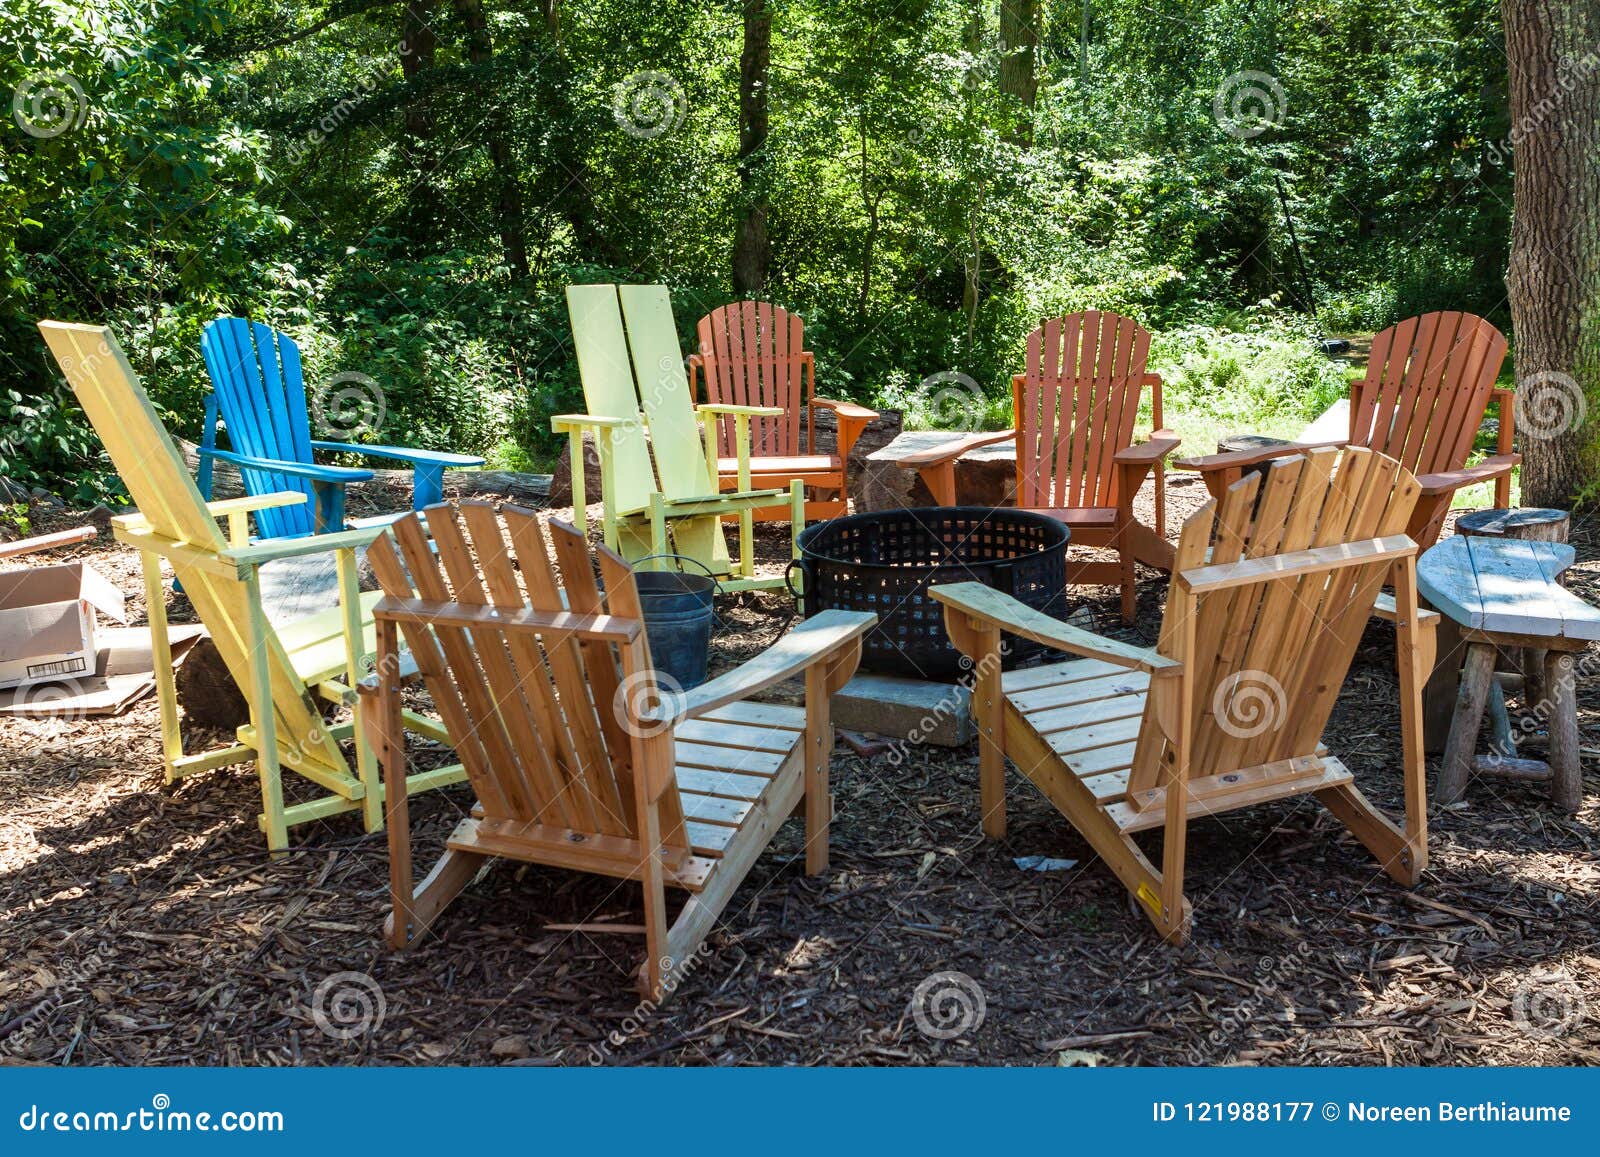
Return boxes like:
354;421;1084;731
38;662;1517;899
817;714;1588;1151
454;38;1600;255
550;285;805;591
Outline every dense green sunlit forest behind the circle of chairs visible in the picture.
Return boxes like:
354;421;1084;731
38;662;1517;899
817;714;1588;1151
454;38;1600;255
0;0;1512;496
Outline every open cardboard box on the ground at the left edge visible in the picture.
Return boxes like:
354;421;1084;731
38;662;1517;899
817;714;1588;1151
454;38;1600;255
0;562;126;688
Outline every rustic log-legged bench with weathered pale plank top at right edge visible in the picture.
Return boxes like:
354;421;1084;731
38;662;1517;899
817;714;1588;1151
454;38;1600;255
1416;534;1600;811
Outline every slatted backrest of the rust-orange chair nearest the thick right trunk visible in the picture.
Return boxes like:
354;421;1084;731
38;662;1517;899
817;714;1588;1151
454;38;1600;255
1350;312;1506;474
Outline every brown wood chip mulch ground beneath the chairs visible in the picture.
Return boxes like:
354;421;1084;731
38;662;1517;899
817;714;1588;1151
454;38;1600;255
0;486;1600;1064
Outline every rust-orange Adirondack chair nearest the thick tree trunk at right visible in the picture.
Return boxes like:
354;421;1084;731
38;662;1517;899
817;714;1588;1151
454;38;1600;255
1173;312;1522;550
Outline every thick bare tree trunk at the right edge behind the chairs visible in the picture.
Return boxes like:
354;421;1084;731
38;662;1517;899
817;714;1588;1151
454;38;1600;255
1501;0;1600;507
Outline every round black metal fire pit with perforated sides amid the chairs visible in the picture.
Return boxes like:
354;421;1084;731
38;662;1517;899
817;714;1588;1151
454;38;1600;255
790;506;1070;679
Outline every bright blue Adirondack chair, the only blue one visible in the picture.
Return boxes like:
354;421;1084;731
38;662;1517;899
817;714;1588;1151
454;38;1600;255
198;317;483;538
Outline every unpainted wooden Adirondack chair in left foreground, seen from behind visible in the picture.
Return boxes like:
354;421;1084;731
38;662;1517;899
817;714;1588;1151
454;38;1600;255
362;502;875;999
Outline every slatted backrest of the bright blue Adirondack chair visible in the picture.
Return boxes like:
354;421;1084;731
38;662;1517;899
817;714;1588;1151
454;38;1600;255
200;317;315;538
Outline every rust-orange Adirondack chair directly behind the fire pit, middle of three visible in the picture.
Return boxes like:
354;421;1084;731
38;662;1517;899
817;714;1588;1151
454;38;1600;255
901;310;1178;623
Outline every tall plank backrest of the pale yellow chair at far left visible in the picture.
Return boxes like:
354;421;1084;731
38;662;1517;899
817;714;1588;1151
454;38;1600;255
38;322;347;773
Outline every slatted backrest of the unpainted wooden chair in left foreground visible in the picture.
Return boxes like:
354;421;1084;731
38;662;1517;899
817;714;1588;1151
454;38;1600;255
368;502;686;847
